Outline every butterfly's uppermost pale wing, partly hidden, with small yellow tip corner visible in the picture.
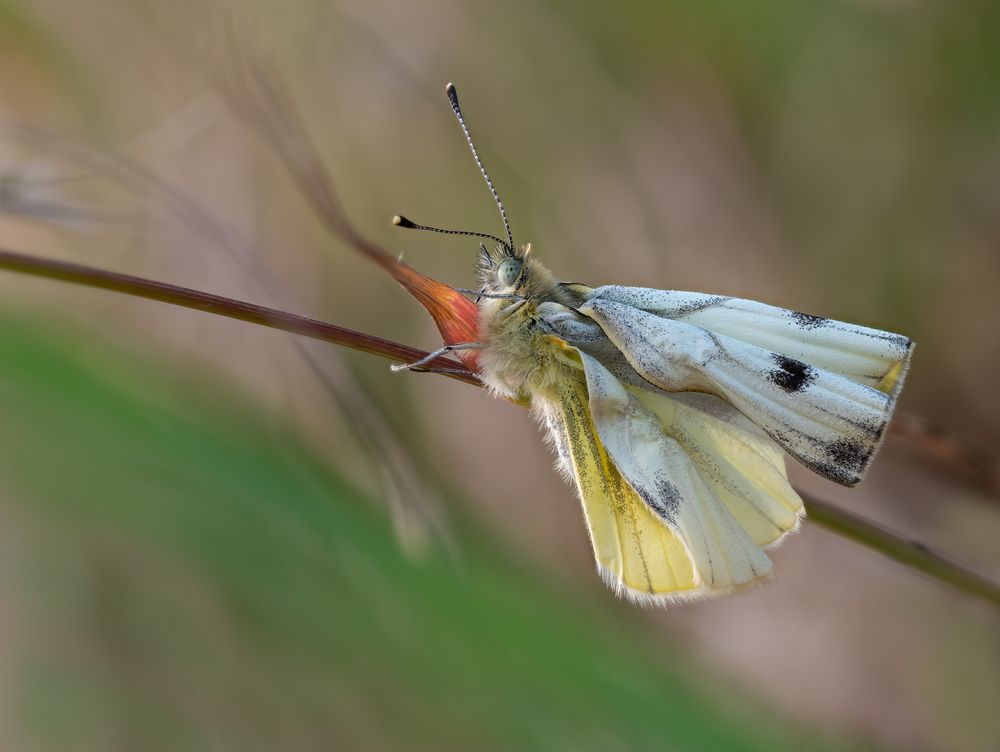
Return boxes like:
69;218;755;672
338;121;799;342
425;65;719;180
590;285;913;397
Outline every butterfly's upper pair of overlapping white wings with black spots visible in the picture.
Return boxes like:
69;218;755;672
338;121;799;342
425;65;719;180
578;288;912;485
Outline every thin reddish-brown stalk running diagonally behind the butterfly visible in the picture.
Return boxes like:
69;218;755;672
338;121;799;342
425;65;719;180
0;249;1000;608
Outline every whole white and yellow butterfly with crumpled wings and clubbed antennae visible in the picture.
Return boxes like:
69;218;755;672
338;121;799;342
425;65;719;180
394;84;914;604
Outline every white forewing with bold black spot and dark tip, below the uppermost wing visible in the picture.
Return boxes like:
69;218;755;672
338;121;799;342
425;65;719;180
578;295;894;485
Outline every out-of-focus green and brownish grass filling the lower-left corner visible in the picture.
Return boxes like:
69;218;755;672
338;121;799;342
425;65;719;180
0;317;880;750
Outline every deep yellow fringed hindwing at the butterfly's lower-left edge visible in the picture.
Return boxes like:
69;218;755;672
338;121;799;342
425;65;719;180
540;378;705;602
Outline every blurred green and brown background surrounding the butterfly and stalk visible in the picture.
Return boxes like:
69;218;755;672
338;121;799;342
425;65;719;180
0;0;1000;752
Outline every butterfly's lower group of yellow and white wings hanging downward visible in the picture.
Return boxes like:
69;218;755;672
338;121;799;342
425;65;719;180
536;353;780;602
